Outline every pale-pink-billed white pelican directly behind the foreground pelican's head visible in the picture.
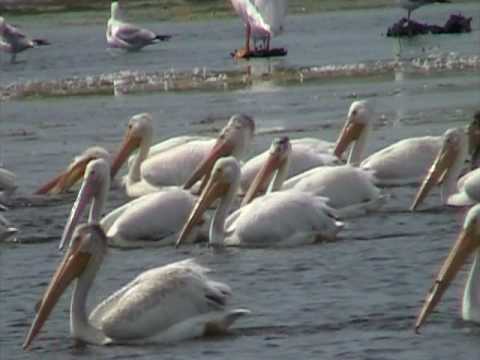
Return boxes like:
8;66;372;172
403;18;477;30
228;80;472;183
60;159;200;247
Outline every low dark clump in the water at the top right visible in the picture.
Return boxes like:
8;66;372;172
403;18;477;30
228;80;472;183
387;14;472;37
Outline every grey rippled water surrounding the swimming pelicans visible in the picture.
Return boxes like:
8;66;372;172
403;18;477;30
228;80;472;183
0;5;480;360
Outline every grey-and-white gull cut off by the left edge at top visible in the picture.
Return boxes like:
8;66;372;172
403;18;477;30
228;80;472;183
0;16;50;64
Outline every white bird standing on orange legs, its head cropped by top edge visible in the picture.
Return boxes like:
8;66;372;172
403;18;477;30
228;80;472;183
231;0;288;59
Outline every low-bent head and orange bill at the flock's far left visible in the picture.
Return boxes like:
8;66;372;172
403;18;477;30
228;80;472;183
35;146;111;195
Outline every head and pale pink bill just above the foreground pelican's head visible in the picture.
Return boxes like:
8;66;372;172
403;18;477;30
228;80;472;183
59;159;110;249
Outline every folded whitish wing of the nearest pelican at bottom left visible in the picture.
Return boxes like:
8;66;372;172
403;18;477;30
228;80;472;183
92;260;231;340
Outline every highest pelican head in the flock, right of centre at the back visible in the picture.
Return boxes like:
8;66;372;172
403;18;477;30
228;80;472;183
333;100;373;163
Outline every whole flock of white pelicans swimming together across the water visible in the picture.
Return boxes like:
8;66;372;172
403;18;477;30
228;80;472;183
0;100;480;348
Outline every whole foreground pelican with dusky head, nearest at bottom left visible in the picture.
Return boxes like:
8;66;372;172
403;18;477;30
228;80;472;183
23;222;249;349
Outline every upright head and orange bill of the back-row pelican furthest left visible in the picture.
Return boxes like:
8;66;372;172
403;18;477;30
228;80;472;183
112;113;153;178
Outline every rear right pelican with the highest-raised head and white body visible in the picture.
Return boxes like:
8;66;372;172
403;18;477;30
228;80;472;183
334;100;442;185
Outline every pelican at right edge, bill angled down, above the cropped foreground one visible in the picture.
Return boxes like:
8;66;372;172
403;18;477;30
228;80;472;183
411;128;480;211
